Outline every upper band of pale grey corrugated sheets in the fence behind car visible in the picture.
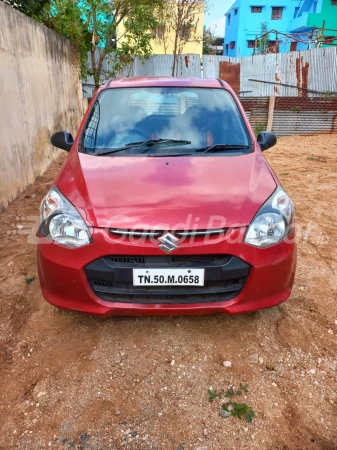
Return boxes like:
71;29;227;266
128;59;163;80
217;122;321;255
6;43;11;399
83;47;337;97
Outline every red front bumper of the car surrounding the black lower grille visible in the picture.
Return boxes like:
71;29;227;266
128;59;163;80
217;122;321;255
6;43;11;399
38;228;296;316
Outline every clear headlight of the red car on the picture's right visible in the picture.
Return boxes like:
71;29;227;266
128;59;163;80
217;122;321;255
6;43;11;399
245;187;294;247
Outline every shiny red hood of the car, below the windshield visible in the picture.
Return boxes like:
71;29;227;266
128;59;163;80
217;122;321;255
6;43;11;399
58;151;276;230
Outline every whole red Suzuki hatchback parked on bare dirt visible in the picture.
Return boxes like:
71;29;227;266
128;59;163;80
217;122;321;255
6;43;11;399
38;78;296;316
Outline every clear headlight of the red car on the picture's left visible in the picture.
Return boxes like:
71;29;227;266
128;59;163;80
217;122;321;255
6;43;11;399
40;187;91;248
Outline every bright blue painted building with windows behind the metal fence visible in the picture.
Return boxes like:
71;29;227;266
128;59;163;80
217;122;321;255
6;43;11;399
224;0;326;57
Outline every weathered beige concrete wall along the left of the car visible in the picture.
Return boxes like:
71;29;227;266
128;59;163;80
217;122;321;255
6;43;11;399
0;2;82;212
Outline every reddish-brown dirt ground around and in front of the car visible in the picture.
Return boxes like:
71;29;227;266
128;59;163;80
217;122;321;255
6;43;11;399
0;135;337;450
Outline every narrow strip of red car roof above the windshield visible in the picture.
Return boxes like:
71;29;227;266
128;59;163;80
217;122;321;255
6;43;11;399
102;77;230;89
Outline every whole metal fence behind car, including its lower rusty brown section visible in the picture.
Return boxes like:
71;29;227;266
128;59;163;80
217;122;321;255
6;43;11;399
83;47;337;136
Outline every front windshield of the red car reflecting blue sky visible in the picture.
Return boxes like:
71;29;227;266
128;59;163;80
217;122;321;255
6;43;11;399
80;87;251;156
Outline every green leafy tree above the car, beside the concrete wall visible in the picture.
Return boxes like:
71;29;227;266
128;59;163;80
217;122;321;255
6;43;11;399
44;0;163;88
